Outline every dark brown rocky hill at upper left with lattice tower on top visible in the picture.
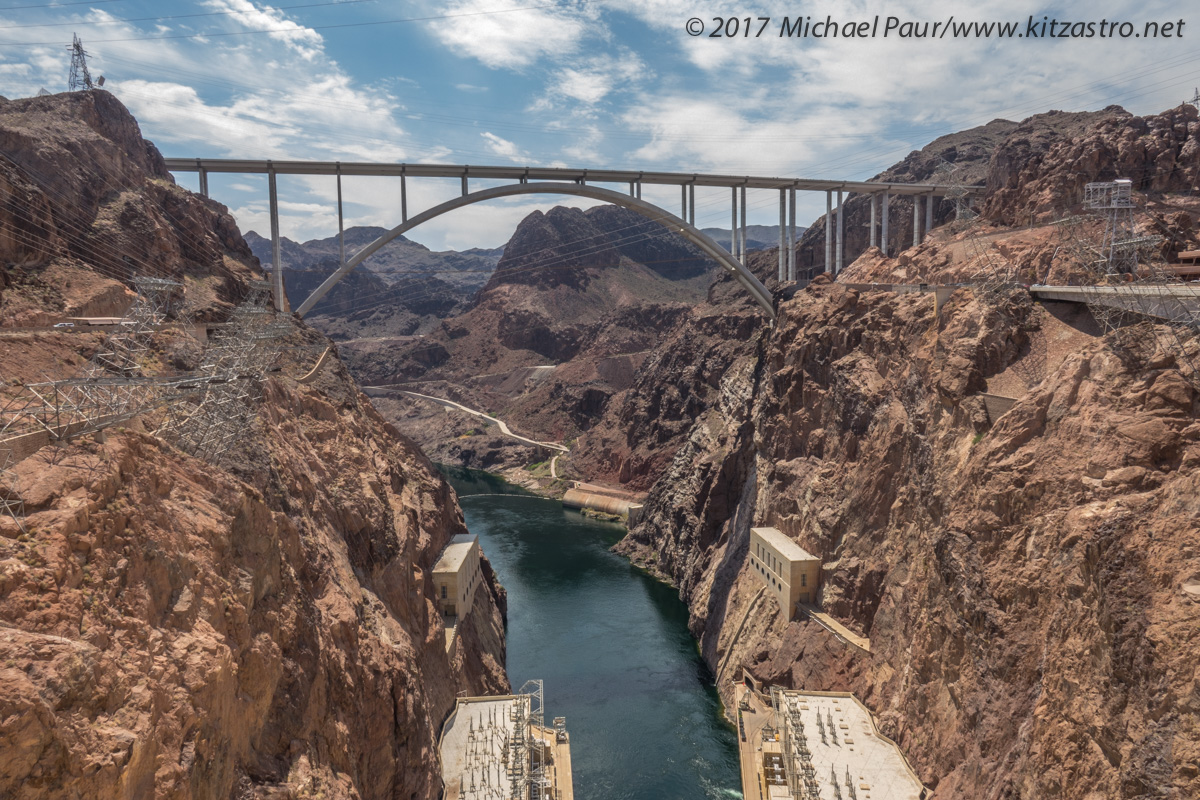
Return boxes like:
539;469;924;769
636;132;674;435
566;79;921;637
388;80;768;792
0;91;257;326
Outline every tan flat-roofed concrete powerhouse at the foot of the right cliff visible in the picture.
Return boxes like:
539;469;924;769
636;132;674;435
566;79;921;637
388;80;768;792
734;684;926;800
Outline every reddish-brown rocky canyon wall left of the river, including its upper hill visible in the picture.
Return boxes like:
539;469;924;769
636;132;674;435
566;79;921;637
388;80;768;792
0;91;508;800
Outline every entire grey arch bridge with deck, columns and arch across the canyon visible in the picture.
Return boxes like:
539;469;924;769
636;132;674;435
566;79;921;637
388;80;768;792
166;158;983;319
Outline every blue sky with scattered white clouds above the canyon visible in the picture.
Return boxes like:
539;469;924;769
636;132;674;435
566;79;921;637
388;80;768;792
0;0;1200;249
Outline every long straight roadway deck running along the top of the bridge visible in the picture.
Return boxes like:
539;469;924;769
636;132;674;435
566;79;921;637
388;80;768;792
166;158;984;194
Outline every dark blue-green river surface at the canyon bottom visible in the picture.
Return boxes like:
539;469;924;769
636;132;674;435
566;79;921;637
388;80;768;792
448;469;742;800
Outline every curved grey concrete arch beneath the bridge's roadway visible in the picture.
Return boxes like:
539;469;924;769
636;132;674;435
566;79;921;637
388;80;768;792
296;182;775;321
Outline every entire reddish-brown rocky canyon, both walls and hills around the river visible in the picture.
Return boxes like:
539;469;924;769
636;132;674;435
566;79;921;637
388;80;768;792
0;91;1200;800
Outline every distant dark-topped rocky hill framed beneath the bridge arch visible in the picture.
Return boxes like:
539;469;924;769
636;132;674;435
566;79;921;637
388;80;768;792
338;206;715;467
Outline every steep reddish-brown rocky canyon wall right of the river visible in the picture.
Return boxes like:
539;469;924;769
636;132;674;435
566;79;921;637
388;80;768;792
597;109;1200;800
